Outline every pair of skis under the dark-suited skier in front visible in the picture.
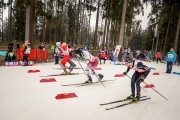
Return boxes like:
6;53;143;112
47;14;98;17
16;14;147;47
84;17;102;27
100;96;151;110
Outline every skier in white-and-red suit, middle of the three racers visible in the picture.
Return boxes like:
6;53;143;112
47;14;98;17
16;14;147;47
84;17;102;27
75;49;104;83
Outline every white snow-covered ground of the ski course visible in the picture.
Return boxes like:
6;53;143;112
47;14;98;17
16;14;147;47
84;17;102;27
0;61;180;120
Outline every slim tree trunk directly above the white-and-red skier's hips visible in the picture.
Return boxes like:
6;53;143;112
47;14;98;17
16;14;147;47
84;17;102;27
93;0;100;49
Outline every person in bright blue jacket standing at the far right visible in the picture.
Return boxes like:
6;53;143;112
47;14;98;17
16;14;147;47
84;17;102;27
166;48;176;73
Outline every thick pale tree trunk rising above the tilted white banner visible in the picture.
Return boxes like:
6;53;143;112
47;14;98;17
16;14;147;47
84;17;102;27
119;0;127;45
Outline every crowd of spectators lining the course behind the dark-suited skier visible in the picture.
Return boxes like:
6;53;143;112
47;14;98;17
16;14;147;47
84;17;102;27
98;47;180;65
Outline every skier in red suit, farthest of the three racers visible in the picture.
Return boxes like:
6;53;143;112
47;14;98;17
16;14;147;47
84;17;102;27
59;43;76;75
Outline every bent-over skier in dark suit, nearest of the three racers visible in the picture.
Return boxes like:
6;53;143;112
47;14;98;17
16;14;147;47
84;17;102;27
123;59;150;101
